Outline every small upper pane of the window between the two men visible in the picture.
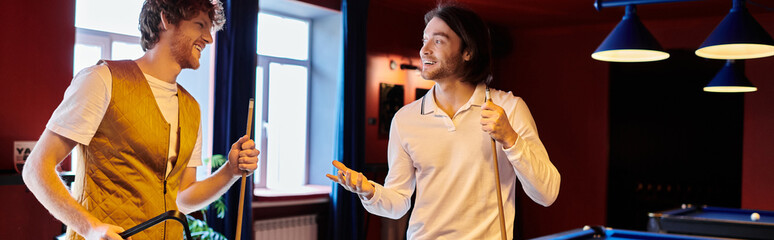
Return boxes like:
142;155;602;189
258;13;309;60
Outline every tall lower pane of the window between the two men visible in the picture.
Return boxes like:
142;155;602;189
266;63;308;188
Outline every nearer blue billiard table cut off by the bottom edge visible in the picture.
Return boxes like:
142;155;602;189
532;226;716;240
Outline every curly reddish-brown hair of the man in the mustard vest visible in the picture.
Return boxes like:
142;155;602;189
139;0;226;51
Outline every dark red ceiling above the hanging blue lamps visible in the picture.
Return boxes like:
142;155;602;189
384;0;774;28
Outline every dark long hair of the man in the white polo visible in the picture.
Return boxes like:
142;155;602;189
425;4;492;85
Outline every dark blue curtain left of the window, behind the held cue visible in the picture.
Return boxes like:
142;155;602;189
208;0;258;239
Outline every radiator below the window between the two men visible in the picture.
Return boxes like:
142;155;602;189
253;215;317;240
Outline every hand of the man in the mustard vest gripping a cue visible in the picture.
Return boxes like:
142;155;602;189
228;135;261;177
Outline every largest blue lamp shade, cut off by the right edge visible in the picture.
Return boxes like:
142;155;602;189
696;0;774;59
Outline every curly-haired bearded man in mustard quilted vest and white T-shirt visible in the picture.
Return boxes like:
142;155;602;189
23;0;259;240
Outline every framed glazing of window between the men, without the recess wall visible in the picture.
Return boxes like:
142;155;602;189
254;12;310;189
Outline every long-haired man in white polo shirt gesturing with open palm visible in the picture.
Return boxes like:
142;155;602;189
328;5;561;239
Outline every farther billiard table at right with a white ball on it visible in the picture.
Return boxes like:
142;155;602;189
648;205;774;239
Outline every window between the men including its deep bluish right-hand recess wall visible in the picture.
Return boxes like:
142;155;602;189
253;1;343;193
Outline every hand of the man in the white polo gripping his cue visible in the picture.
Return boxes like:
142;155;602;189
481;99;519;148
